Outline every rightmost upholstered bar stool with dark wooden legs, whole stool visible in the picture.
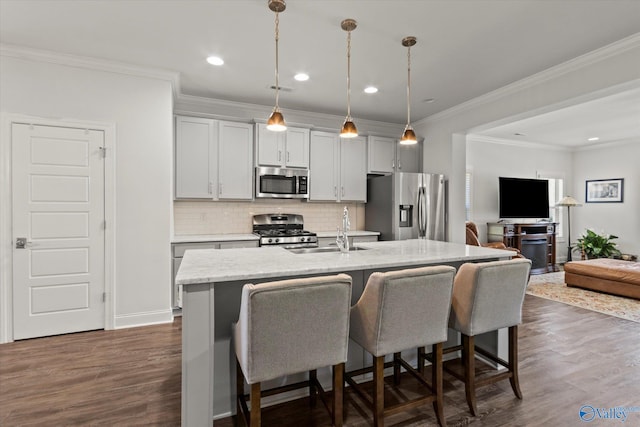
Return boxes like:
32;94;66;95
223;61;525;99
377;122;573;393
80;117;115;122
445;258;531;416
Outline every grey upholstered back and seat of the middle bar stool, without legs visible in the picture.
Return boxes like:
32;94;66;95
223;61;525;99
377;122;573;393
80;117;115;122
351;266;455;356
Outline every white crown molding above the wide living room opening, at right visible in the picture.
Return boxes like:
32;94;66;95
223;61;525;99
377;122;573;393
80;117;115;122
417;32;640;124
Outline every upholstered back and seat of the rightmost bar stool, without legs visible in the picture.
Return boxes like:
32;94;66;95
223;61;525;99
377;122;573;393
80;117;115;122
450;258;531;336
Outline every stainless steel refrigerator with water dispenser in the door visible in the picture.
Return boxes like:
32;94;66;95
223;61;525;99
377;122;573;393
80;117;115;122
365;173;446;241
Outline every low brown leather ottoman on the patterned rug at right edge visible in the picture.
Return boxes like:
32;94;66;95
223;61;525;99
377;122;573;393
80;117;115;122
564;258;640;299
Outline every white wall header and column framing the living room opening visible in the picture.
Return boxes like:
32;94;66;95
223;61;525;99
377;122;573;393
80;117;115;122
414;35;640;242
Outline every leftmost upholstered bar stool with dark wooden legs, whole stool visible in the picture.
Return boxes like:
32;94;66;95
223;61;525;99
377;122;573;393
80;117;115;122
232;274;351;427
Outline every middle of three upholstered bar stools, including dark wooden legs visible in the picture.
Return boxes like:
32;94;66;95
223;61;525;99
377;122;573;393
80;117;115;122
345;266;455;426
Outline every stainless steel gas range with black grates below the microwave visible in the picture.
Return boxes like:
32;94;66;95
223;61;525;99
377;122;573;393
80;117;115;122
253;214;318;248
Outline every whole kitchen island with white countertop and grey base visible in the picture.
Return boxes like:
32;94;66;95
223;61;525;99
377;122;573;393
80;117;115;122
176;239;515;426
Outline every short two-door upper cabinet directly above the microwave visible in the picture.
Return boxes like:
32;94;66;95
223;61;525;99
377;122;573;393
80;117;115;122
256;123;309;169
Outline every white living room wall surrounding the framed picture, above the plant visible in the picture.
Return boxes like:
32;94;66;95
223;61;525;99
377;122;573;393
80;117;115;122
571;140;640;255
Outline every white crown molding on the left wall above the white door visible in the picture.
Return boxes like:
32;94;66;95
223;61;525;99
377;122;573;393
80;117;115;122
0;43;181;98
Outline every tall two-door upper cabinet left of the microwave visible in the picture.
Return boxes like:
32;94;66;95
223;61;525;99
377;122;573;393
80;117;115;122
175;116;253;200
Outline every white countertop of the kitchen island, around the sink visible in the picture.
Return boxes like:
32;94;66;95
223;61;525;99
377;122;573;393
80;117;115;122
176;239;516;285
